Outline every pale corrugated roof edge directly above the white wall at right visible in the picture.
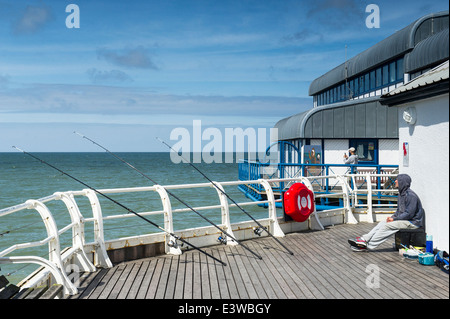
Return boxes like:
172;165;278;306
381;60;449;105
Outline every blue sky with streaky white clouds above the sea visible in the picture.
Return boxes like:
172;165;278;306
0;0;448;152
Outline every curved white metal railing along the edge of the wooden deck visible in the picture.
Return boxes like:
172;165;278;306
0;174;396;295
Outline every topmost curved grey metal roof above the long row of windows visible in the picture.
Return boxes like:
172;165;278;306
309;11;449;96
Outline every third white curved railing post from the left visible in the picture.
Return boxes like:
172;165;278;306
84;189;113;268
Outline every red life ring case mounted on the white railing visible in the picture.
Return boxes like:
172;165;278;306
284;183;314;222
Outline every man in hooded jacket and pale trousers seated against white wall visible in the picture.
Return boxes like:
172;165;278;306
348;174;424;251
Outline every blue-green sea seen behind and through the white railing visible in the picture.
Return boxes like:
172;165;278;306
0;152;268;283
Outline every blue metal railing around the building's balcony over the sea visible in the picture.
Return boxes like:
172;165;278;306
239;160;398;200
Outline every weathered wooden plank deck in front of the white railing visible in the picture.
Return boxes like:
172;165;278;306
70;223;449;300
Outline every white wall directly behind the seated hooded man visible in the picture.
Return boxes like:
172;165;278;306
399;94;449;252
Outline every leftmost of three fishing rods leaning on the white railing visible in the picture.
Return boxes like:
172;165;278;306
13;146;227;266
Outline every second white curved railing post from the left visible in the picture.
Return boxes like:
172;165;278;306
54;192;96;272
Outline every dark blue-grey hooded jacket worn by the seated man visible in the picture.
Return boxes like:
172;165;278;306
392;174;425;227
